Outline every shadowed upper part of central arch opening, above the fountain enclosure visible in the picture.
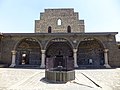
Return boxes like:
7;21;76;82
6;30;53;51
46;38;73;56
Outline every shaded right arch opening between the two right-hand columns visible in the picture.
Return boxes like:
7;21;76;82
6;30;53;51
77;38;105;67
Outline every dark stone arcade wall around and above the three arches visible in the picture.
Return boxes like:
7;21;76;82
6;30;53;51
0;33;120;67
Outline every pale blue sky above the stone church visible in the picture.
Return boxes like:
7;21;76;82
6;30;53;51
0;0;120;41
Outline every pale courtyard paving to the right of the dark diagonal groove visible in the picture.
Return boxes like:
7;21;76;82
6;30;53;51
79;68;120;90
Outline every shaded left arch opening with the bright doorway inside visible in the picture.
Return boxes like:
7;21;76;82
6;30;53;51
14;38;41;66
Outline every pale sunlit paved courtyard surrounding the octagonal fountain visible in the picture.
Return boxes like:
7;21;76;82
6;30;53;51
0;68;120;90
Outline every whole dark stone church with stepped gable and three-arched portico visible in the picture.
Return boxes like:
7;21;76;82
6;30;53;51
0;8;120;68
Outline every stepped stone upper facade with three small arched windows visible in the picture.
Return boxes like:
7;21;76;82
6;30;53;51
35;8;85;33
